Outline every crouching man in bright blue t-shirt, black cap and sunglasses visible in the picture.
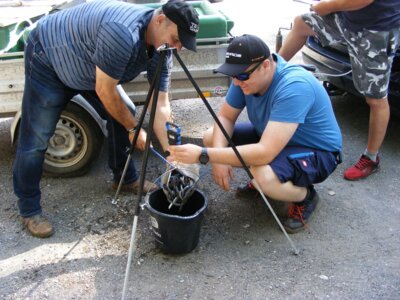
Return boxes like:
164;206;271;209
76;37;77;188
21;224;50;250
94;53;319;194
169;35;342;233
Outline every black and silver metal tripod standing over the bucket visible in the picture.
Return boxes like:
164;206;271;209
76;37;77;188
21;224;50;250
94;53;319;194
114;44;299;299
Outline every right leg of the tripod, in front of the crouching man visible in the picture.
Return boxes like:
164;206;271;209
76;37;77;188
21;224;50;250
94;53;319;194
174;50;299;255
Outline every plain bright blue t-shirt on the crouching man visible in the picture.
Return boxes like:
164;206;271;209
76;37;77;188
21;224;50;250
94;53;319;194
226;54;342;152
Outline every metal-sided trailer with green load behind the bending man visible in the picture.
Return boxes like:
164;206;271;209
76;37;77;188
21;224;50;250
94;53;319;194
0;0;233;177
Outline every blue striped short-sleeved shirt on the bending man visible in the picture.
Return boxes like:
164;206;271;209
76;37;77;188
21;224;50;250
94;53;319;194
38;0;172;91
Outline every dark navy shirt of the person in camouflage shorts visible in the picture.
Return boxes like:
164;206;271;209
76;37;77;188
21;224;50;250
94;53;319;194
341;0;400;32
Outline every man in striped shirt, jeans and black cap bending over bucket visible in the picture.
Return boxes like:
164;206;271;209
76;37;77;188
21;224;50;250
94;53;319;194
13;0;199;237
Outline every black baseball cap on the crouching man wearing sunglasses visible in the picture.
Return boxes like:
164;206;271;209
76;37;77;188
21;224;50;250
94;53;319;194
215;34;271;76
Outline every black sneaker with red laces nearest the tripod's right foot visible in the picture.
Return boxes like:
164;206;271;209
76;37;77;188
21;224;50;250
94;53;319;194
283;186;319;233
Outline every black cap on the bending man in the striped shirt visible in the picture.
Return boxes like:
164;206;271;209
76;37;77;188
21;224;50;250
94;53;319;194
162;0;199;52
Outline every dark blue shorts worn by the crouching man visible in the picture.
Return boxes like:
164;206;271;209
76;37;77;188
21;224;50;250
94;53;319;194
232;122;341;186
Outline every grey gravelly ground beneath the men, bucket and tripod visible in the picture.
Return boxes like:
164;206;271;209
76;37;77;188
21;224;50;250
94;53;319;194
0;96;400;299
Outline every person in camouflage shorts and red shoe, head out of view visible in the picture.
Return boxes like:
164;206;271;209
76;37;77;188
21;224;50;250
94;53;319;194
279;0;400;180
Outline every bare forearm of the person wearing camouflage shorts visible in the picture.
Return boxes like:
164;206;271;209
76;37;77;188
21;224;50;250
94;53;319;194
311;0;374;16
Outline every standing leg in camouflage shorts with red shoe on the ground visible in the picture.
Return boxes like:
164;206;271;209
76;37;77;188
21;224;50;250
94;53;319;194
343;29;400;180
